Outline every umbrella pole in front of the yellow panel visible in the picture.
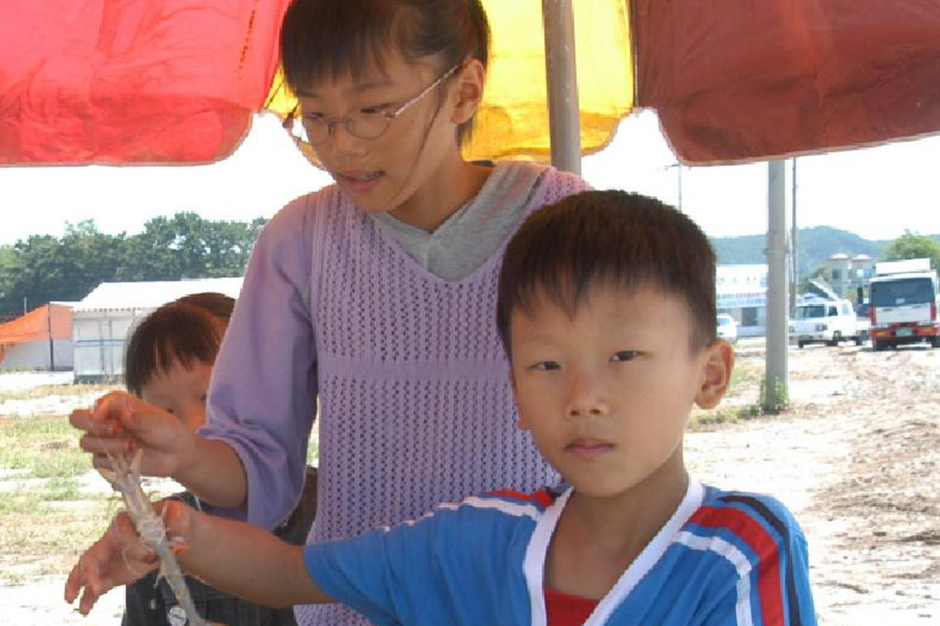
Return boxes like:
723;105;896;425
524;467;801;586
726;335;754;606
542;0;581;174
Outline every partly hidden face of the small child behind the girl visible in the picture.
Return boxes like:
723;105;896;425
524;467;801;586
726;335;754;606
140;361;212;430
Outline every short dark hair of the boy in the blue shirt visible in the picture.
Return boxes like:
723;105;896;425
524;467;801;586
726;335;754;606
496;191;716;358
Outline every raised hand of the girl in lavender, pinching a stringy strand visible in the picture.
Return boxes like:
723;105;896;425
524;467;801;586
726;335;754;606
69;391;197;476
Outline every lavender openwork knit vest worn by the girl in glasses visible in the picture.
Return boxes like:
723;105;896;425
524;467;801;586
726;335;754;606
297;168;587;626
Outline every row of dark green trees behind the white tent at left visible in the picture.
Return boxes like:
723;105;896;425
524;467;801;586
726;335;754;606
0;212;265;322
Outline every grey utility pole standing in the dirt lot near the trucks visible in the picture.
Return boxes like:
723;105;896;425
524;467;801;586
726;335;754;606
763;161;788;413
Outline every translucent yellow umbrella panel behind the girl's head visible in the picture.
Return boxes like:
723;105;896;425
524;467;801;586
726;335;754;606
266;0;634;162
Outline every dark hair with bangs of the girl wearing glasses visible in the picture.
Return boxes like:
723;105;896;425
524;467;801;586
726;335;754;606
281;0;490;143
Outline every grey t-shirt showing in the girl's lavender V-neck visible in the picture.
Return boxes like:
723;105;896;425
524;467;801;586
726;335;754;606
373;161;545;281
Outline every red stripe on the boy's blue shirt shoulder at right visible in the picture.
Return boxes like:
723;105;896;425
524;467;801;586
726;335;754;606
689;506;786;626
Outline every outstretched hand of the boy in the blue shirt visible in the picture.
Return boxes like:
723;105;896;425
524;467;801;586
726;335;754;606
65;511;157;615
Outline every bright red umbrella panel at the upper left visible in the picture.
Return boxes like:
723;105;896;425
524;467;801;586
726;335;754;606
0;0;288;164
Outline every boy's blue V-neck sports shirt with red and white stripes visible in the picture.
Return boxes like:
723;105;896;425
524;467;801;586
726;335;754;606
305;481;816;626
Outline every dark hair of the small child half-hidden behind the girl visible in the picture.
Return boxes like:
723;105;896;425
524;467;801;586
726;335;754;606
124;293;235;396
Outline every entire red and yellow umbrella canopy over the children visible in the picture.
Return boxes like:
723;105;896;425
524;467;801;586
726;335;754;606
0;0;940;164
